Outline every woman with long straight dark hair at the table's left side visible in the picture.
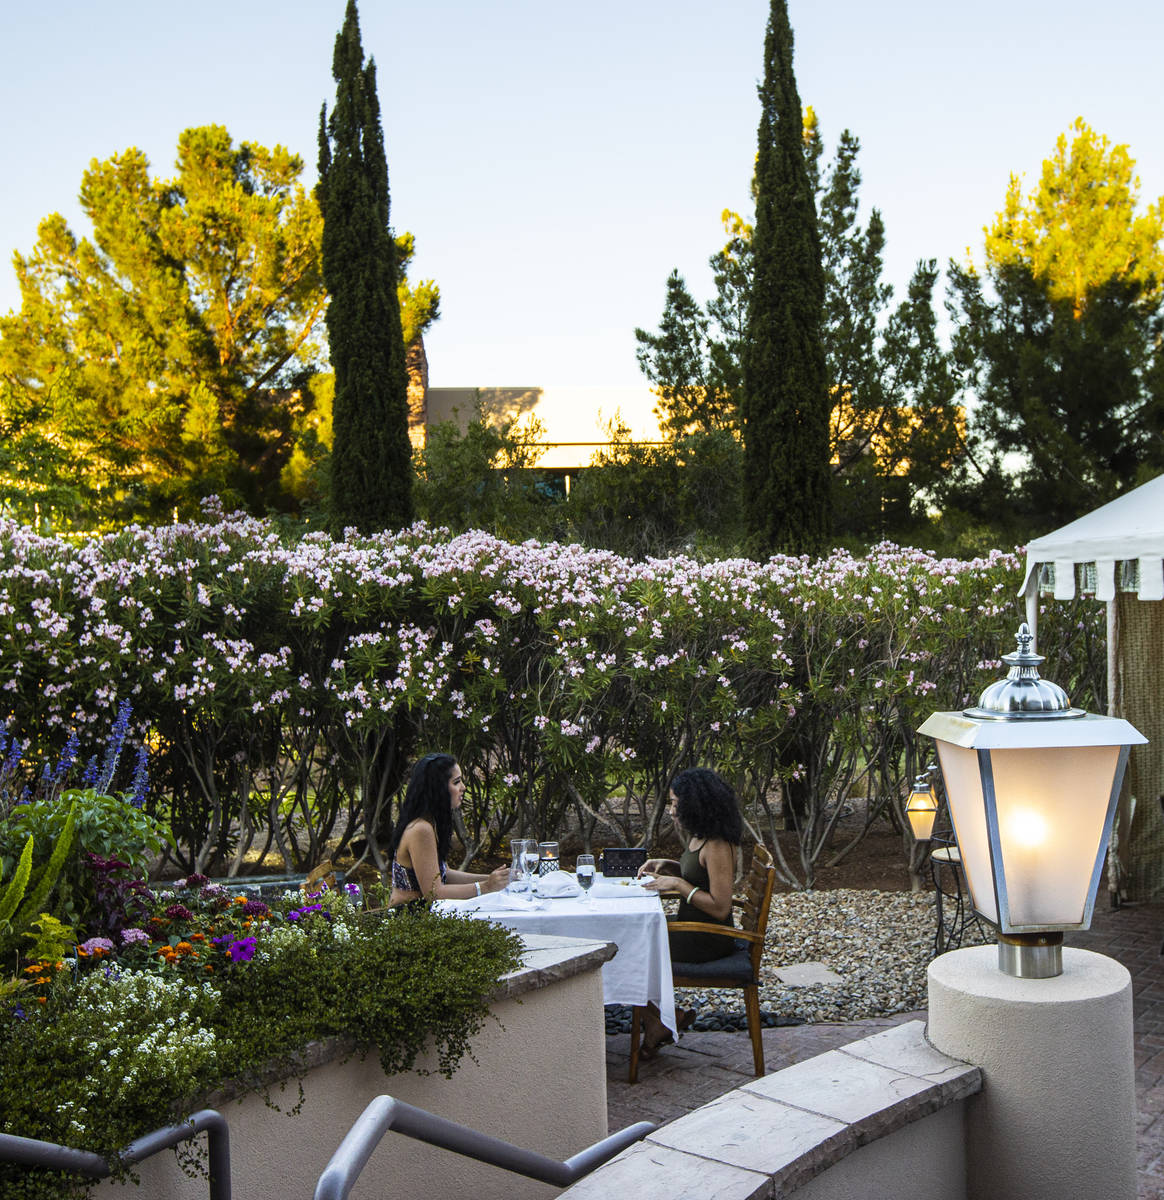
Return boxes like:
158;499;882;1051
388;754;509;906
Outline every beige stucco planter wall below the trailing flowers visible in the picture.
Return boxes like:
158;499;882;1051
94;937;613;1200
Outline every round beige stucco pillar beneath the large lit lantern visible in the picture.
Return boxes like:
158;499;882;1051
926;946;1136;1200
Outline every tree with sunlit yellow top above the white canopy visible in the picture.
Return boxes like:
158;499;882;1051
950;119;1164;529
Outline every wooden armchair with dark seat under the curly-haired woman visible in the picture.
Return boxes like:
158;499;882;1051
630;846;776;1084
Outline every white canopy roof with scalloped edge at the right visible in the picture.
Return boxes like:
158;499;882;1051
1019;475;1164;610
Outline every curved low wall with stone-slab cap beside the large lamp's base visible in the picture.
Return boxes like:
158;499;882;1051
562;1021;982;1200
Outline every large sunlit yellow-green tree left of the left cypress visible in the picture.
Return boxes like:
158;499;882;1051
0;126;325;521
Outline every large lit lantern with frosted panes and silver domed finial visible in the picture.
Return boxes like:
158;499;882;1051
911;624;1147;979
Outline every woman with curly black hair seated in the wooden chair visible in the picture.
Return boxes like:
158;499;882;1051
638;767;744;1058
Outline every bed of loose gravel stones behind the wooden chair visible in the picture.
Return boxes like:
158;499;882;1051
607;888;971;1033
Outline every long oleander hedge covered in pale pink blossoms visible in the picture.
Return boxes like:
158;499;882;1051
0;509;1103;886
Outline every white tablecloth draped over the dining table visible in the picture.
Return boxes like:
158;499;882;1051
433;878;676;1032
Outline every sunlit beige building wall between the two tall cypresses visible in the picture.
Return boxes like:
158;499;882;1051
427;386;662;470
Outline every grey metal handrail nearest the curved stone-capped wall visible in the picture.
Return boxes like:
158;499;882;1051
314;1096;655;1200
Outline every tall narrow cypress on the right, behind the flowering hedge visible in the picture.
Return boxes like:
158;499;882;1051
740;0;832;553
